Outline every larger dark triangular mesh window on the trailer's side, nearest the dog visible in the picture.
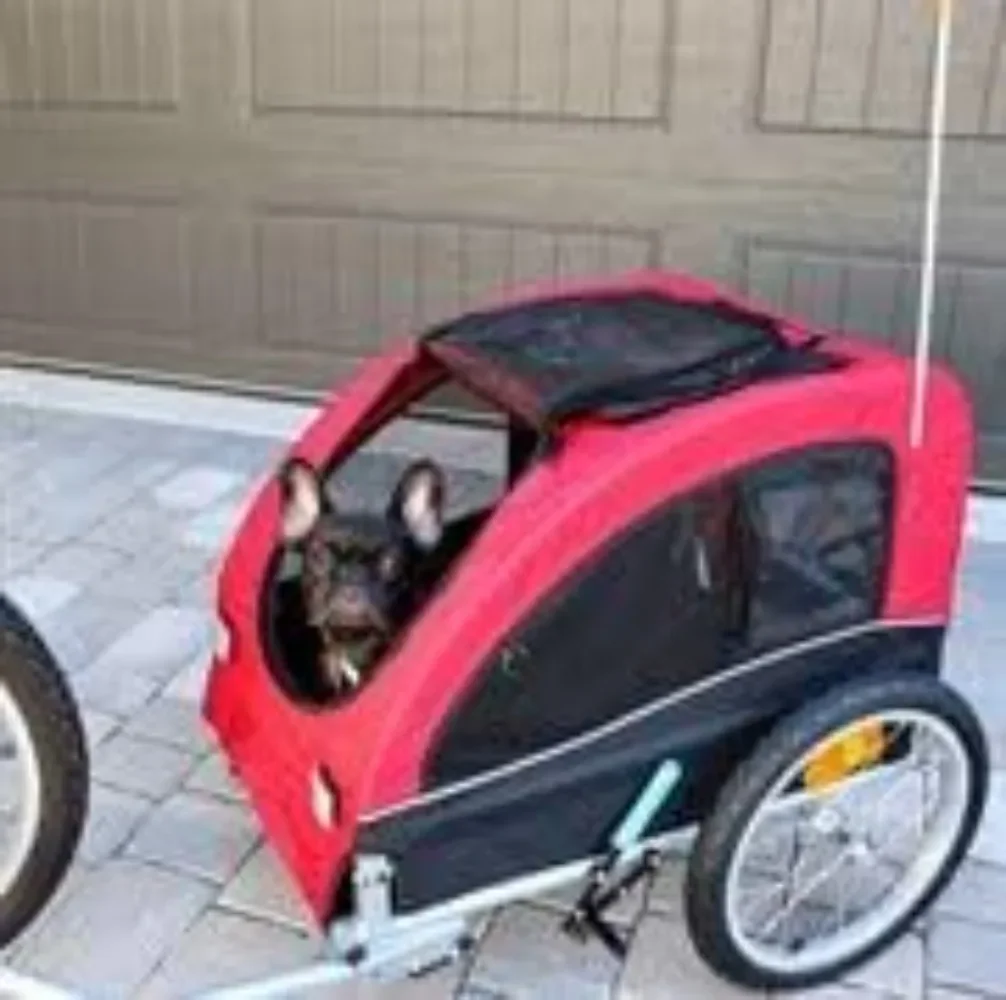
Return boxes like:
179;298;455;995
428;491;730;785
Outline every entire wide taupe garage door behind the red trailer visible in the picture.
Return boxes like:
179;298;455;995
0;0;1006;476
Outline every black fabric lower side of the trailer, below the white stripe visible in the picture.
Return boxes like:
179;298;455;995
358;628;943;912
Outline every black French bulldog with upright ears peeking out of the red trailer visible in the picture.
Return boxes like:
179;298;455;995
280;459;445;694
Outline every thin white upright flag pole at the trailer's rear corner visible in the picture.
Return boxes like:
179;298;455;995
909;0;954;448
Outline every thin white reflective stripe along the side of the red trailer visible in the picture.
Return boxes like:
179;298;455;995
360;618;947;824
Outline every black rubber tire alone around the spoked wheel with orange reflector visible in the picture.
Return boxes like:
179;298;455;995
685;674;989;990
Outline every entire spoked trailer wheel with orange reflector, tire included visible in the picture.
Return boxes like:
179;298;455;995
685;674;989;989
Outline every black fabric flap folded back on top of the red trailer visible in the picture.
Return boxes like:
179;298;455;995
426;293;835;425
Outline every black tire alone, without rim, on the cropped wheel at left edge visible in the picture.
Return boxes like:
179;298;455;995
0;596;89;947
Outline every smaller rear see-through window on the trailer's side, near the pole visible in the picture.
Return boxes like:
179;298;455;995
741;445;891;650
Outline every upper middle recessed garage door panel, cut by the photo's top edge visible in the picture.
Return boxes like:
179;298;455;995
250;0;671;122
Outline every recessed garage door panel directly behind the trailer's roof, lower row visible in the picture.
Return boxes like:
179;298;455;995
257;208;655;354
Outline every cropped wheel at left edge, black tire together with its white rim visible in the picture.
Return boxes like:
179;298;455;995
0;597;89;947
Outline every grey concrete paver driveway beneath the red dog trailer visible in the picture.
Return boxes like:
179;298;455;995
0;390;1006;1000
